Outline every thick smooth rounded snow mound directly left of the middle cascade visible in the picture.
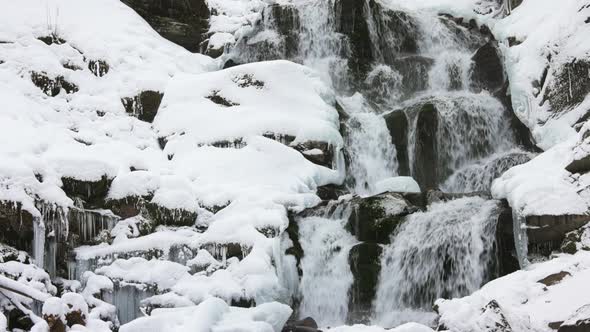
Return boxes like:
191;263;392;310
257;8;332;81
154;60;342;148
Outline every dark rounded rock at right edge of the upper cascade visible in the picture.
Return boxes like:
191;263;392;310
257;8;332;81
471;42;505;92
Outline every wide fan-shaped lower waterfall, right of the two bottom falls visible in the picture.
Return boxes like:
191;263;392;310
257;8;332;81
374;197;498;326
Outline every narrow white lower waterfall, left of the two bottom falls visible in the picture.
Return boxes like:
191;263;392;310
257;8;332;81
298;203;356;326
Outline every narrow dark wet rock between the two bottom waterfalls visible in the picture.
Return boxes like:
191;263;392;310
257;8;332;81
348;242;383;323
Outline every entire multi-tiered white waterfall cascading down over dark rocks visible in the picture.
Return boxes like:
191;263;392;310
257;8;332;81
229;0;528;327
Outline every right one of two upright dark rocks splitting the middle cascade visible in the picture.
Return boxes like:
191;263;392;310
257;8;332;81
413;103;439;190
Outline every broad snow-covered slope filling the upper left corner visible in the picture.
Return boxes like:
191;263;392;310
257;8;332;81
0;0;215;215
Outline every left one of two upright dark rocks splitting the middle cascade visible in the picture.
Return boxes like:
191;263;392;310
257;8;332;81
385;110;410;176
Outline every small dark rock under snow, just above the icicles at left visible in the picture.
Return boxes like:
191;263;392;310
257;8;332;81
61;175;113;207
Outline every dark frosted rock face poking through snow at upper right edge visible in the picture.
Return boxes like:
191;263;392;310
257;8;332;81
542;59;590;113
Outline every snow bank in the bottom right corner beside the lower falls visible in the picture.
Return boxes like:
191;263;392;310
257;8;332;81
436;251;590;332
